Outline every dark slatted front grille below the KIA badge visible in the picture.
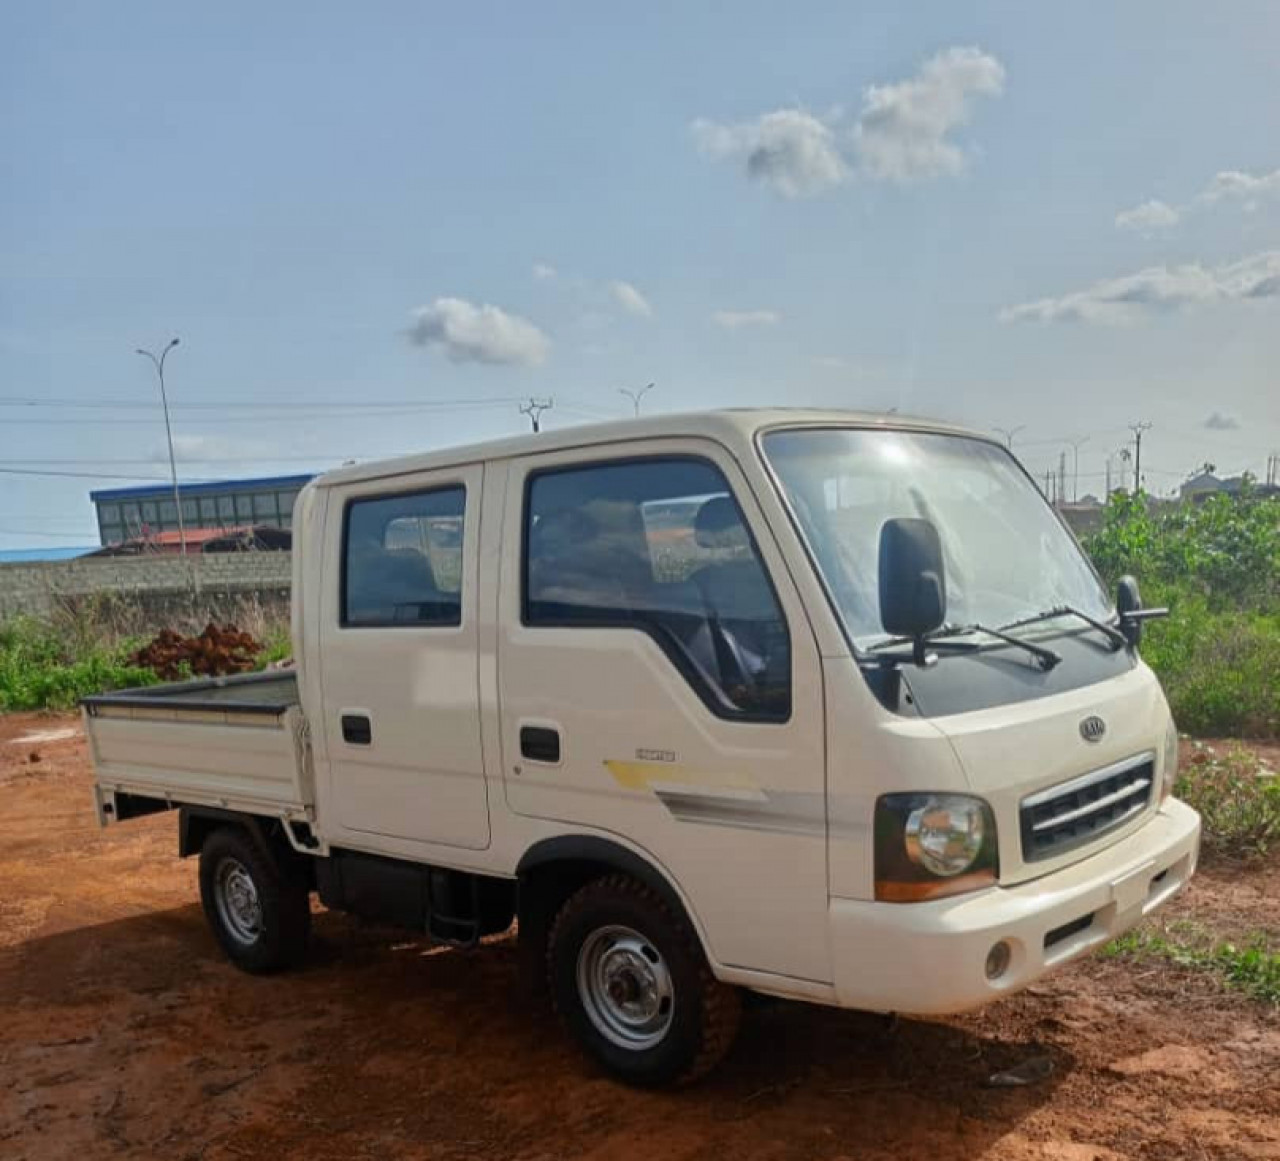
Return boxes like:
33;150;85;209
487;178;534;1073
1021;754;1156;863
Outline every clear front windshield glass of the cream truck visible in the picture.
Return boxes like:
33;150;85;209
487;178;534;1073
763;429;1111;648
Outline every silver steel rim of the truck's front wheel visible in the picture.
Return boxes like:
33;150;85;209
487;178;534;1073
577;925;676;1051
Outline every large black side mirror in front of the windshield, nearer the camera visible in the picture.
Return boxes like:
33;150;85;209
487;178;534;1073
879;516;947;664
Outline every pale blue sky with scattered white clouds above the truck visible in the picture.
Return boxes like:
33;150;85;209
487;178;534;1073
0;0;1280;548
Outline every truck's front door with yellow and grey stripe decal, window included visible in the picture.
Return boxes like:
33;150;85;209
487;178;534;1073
488;440;831;981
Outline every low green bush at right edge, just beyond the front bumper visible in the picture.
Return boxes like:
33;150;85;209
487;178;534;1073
1174;742;1280;858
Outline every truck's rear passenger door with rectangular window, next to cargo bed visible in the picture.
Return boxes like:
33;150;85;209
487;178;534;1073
320;466;489;849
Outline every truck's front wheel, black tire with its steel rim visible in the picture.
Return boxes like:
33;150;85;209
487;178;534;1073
547;874;741;1087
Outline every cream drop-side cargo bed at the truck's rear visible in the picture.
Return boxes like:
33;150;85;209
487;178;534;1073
82;671;315;823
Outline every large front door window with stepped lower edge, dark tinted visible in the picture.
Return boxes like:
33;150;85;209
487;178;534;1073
524;458;791;721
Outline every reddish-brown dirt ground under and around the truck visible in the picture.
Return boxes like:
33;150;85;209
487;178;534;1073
0;716;1280;1161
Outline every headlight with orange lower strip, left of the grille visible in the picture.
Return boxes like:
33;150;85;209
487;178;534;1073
876;794;998;902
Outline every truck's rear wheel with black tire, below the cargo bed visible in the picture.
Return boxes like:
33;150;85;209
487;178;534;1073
200;827;311;974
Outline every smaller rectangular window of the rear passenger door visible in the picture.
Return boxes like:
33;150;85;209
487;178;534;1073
342;488;466;626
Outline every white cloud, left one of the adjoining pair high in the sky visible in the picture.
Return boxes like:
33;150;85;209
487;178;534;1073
692;109;850;197
